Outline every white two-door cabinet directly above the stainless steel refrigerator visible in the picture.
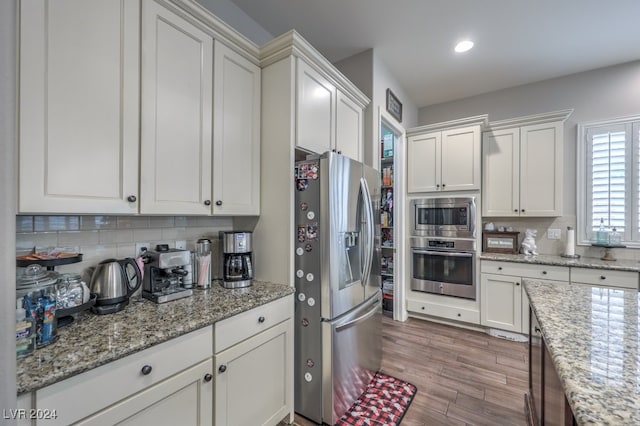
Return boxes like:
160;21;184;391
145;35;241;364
296;59;364;161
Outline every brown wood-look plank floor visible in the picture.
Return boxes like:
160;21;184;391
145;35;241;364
295;317;528;426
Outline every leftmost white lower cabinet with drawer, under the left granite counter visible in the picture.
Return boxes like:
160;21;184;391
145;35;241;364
34;326;214;425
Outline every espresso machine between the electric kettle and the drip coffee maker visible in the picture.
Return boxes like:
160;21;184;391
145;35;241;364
142;244;193;303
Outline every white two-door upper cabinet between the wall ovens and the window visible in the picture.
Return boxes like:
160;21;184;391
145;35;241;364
482;110;573;217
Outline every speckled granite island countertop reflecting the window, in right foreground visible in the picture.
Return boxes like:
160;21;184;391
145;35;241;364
523;279;640;425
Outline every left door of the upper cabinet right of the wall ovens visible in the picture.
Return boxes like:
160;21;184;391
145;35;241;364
482;128;520;216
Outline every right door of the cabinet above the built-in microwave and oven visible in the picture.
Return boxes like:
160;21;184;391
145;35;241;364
440;126;481;191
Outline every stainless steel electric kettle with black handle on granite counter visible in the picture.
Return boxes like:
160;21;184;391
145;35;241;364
89;257;142;314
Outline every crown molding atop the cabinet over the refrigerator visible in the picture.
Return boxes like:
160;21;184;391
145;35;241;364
260;30;371;108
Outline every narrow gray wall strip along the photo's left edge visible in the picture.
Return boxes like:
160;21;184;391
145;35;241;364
0;0;17;424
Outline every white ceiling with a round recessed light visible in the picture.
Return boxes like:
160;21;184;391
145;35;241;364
225;0;640;107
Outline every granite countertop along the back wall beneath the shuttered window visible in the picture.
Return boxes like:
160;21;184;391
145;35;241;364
480;252;640;272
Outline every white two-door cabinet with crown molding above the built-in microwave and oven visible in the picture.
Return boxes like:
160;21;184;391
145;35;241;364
407;115;487;193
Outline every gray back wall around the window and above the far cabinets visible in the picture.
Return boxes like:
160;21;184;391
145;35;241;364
418;61;640;258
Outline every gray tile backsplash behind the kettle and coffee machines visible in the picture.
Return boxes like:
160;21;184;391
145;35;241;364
16;215;238;273
